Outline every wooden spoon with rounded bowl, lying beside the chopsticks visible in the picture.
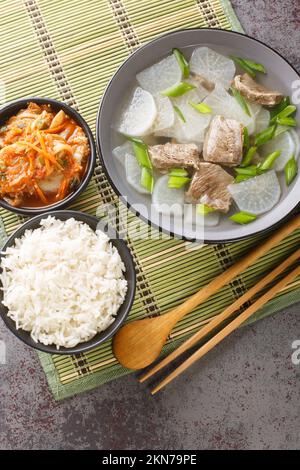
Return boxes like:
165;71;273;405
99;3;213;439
113;215;300;370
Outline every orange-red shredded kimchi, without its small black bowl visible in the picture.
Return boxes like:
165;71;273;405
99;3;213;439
0;103;90;207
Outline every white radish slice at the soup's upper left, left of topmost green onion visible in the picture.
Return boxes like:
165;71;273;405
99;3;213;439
136;54;182;95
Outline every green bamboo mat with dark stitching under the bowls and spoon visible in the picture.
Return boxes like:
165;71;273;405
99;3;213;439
0;0;300;400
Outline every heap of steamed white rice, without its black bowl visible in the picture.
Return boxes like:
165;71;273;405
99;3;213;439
0;216;127;348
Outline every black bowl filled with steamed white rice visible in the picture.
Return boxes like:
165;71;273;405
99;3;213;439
0;210;136;354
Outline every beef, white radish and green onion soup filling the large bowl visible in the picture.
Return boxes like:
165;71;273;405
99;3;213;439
113;46;299;227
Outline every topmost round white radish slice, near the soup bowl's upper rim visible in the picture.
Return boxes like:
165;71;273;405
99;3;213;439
190;47;235;89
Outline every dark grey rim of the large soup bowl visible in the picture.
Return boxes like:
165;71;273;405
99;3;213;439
96;28;300;244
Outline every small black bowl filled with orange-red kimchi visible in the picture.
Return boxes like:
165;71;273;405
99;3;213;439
0;97;96;215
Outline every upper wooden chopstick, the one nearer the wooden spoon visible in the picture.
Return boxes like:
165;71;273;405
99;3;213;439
139;249;300;382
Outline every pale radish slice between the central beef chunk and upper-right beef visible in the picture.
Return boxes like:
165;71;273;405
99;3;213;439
203;84;254;134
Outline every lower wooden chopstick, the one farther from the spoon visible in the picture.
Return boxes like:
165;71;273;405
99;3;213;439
151;266;300;395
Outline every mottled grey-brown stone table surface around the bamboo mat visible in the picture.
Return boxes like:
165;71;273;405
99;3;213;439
0;0;300;450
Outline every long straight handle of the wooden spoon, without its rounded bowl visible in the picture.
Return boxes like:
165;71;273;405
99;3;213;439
165;215;300;325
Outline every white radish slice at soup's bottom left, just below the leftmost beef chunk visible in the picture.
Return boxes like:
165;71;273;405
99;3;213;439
152;175;185;215
